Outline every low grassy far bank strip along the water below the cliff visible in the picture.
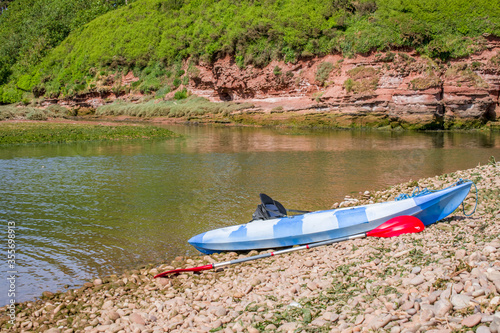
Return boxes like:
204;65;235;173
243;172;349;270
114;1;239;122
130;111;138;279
0;101;500;131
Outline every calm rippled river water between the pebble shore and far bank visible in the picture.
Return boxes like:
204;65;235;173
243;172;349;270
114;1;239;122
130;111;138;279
0;126;500;305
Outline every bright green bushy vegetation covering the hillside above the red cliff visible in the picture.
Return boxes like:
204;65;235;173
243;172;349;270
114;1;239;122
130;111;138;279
0;0;500;104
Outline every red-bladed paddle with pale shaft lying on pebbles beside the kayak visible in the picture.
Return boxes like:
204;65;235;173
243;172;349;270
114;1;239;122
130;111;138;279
155;215;425;278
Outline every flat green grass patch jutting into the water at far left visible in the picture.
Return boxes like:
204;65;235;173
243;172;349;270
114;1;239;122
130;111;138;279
0;122;177;145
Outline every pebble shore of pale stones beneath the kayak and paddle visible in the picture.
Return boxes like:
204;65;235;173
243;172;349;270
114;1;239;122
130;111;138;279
0;161;500;333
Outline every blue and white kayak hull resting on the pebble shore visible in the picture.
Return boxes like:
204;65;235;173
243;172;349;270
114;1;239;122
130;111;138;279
188;181;473;254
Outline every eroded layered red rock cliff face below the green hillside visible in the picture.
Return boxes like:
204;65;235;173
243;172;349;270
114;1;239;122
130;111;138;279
191;38;500;122
